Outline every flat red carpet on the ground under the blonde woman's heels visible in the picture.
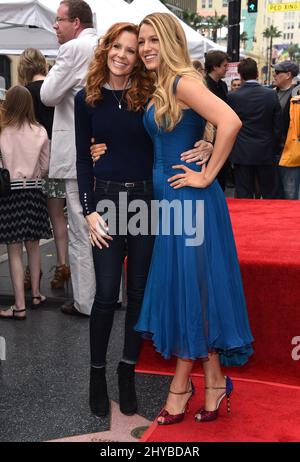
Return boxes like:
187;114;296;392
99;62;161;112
141;377;300;442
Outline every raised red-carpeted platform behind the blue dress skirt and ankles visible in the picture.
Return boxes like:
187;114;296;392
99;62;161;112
137;199;300;386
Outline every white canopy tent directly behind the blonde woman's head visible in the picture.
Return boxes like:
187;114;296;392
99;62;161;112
130;0;226;59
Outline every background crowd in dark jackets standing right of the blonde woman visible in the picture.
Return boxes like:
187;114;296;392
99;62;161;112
193;50;300;200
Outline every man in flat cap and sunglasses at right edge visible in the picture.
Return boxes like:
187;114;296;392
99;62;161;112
273;61;300;199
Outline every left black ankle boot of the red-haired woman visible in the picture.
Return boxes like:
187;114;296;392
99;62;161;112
90;367;109;417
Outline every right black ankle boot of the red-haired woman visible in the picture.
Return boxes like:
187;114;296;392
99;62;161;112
118;362;137;415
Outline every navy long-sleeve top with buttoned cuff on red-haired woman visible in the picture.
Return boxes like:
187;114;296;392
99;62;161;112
75;88;153;216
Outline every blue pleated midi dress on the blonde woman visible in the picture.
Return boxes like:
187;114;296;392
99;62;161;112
135;106;253;365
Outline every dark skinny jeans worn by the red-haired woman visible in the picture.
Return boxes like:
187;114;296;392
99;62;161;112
90;180;154;367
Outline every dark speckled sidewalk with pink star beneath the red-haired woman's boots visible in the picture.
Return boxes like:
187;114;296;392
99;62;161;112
0;241;169;442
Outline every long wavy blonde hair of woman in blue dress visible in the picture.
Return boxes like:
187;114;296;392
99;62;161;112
139;13;203;131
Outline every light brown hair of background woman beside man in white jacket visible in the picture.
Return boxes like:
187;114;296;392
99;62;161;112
18;48;48;85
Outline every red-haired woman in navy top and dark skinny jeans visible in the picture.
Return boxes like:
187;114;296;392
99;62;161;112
75;23;154;416
